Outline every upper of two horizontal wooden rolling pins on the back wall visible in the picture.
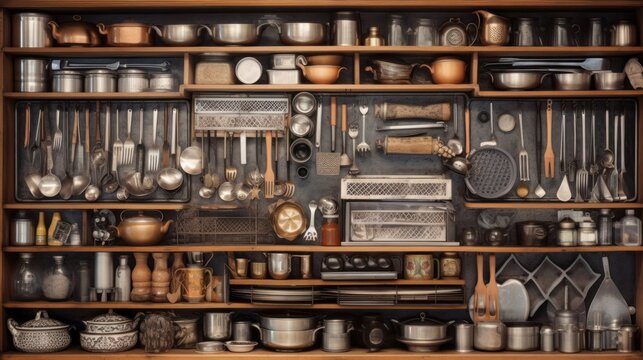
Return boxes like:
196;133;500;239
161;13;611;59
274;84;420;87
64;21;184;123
375;102;452;121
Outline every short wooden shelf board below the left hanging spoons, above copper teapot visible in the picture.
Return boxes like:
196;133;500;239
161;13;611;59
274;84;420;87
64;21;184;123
3;202;189;210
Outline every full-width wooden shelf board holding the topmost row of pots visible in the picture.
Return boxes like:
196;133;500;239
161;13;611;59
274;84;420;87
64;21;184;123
4;45;643;57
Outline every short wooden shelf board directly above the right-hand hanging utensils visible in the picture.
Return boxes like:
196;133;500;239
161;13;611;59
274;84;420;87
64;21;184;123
476;90;643;98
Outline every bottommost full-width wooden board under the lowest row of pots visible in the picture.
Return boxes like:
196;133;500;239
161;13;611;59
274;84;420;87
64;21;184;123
2;347;643;360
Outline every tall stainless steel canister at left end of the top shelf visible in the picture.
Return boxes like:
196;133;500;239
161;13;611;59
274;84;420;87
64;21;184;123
11;12;53;48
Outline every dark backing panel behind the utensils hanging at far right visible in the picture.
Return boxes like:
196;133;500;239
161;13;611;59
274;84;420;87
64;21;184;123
465;98;639;202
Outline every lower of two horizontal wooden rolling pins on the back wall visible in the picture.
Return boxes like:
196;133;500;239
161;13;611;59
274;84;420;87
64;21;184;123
375;136;455;159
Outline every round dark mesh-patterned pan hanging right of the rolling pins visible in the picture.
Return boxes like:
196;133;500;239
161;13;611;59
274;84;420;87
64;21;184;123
464;147;517;199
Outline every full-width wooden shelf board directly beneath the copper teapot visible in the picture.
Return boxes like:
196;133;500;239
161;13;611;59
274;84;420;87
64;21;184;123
4;245;643;253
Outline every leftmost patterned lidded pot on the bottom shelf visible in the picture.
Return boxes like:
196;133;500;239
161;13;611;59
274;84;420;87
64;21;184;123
7;311;71;353
